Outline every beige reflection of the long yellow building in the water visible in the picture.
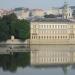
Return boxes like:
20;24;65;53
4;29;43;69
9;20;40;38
30;45;75;66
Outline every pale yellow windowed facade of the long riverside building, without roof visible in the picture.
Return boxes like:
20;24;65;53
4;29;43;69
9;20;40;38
30;21;75;44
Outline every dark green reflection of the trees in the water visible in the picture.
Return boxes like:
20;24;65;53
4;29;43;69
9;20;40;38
0;52;30;72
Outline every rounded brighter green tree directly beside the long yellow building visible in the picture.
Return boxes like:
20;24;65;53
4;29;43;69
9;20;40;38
15;20;30;40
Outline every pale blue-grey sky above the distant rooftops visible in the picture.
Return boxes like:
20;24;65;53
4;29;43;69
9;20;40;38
0;0;75;9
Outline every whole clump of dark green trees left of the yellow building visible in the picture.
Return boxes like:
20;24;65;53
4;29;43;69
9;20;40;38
0;14;30;41
